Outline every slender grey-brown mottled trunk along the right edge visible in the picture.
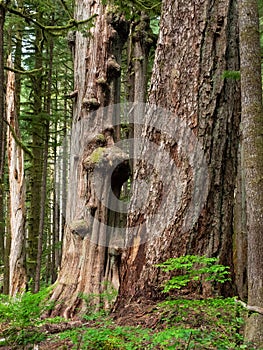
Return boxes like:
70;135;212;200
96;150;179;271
239;0;263;348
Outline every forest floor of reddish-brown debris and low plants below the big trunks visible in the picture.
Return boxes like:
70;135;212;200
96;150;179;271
0;298;258;350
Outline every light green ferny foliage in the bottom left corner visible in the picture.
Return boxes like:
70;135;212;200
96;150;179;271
0;288;58;345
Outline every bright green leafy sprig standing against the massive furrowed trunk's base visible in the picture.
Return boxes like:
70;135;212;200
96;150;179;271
157;255;230;293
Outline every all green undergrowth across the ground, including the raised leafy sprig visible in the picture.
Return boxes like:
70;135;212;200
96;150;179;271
0;256;256;350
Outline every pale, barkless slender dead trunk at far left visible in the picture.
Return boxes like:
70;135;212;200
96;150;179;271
6;58;26;296
